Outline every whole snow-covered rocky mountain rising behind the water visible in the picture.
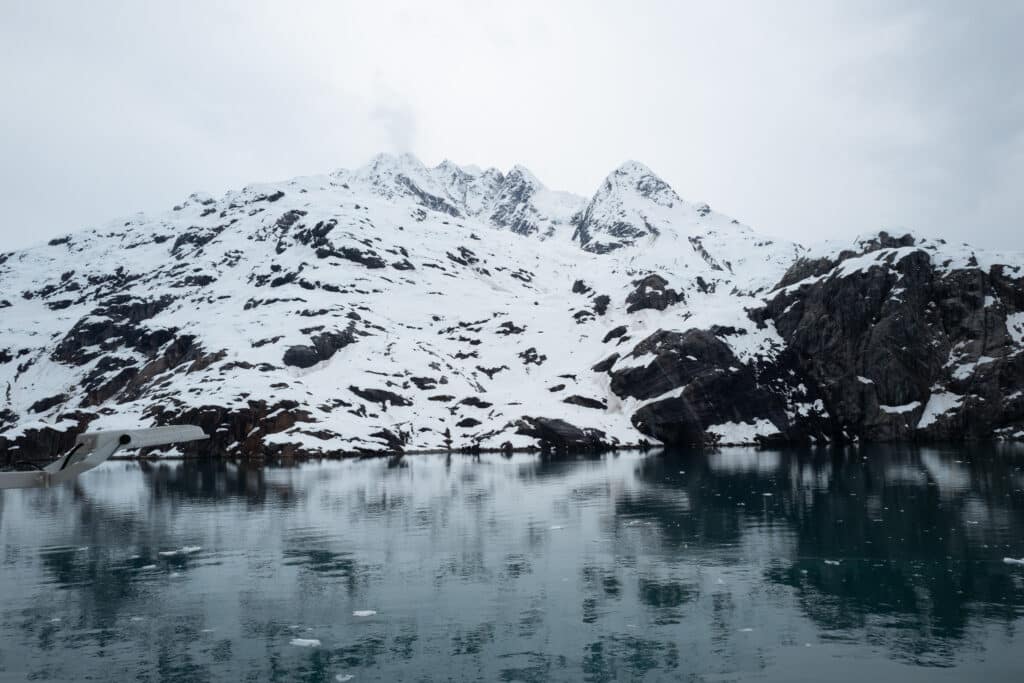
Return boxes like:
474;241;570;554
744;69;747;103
0;156;1024;459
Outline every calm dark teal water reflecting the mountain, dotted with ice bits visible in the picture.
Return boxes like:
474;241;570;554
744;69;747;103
0;446;1024;682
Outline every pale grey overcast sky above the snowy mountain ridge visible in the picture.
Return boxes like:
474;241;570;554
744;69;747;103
0;0;1024;251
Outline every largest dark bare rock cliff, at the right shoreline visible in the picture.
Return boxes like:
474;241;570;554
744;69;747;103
762;232;1024;440
